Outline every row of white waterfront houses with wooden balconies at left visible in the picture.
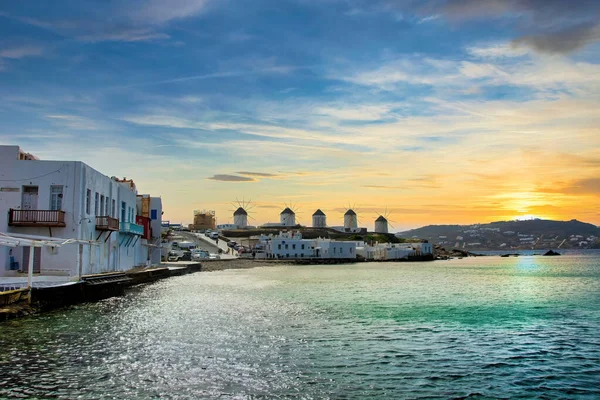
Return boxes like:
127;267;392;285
0;146;162;277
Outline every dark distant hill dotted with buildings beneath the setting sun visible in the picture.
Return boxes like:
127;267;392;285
397;219;600;250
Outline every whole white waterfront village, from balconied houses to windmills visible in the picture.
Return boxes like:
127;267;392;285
0;146;433;287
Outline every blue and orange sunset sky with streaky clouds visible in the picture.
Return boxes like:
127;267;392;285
0;0;600;231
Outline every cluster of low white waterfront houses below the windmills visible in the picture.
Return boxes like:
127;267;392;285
255;231;433;260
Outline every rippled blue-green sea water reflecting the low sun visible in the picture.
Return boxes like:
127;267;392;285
0;253;600;399
